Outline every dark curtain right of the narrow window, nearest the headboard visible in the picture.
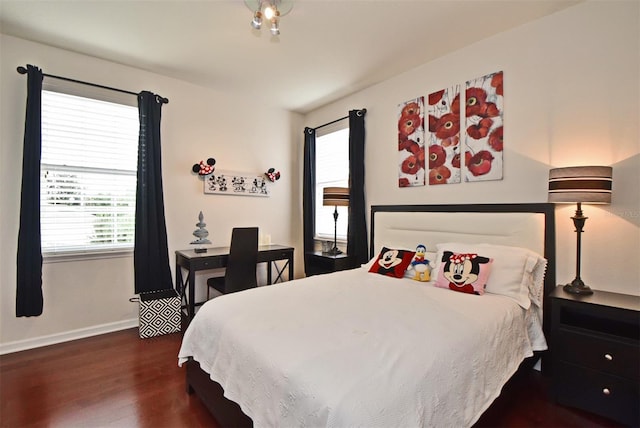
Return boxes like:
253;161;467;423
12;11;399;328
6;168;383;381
347;109;369;264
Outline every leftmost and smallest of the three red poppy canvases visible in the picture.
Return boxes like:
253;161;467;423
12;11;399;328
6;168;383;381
398;97;425;187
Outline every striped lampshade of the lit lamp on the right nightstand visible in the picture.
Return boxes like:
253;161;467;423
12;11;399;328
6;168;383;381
549;166;613;204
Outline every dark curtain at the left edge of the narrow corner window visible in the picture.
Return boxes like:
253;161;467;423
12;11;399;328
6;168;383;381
302;128;316;272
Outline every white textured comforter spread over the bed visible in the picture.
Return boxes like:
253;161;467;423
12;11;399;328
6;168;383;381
178;268;534;428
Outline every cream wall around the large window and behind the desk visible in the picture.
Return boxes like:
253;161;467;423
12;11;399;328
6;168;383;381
0;35;302;353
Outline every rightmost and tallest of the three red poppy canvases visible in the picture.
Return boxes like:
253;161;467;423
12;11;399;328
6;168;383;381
464;71;504;181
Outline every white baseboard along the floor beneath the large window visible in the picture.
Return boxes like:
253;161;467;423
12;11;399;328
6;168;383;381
0;318;138;355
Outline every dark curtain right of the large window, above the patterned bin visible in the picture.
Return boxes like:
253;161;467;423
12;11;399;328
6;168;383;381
133;91;173;294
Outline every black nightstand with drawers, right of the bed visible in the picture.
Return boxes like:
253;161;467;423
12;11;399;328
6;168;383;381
550;286;640;426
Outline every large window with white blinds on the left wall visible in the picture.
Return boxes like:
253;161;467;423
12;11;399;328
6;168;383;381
40;87;139;255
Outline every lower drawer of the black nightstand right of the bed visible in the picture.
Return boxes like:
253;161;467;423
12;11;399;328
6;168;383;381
554;361;640;426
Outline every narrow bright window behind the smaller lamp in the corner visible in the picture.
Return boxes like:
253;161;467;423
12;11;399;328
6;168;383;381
315;122;349;240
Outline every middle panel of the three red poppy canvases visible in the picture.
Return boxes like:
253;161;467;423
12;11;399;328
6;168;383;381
427;85;460;185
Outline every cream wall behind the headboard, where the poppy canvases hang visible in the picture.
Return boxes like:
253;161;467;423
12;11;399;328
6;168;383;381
304;1;640;295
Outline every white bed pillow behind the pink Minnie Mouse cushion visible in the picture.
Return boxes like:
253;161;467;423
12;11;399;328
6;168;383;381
435;242;547;309
